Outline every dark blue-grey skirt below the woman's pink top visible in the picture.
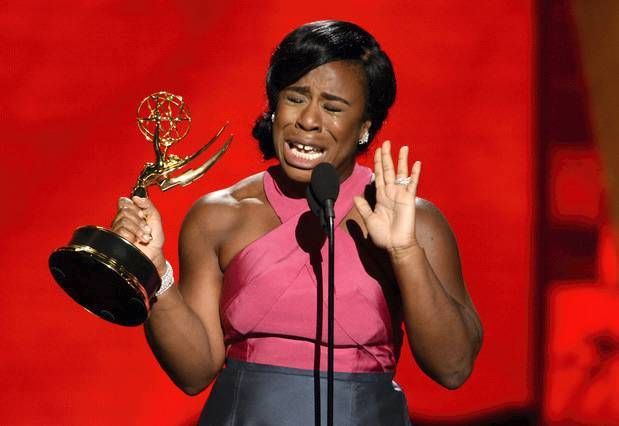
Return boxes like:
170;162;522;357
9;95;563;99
199;359;411;426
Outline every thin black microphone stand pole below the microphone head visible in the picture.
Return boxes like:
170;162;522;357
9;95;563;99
325;199;335;426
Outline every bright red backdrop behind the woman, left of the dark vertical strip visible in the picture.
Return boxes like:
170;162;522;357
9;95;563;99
0;0;535;425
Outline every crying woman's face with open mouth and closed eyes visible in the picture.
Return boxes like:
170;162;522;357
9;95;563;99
273;61;371;182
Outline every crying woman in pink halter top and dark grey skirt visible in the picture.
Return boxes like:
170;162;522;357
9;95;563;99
112;21;482;425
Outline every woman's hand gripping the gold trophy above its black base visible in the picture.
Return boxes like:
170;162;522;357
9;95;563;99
112;197;165;273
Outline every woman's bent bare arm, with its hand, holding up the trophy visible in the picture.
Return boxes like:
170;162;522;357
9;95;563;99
113;198;225;395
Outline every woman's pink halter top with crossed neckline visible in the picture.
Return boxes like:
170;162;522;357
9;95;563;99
220;165;402;372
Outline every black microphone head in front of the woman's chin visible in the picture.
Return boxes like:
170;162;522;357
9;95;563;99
306;163;340;227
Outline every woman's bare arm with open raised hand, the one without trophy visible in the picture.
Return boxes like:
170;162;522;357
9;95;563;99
355;142;482;389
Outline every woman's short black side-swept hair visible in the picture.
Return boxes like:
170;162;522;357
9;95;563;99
252;21;396;159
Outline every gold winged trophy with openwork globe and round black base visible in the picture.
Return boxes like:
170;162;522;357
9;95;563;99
49;92;232;326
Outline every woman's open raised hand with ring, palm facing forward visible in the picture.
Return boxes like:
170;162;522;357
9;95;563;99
354;141;421;254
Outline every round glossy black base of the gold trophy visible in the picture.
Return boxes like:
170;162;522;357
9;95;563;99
49;226;161;326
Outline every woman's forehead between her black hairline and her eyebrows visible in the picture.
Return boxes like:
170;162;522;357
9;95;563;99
290;61;366;100
